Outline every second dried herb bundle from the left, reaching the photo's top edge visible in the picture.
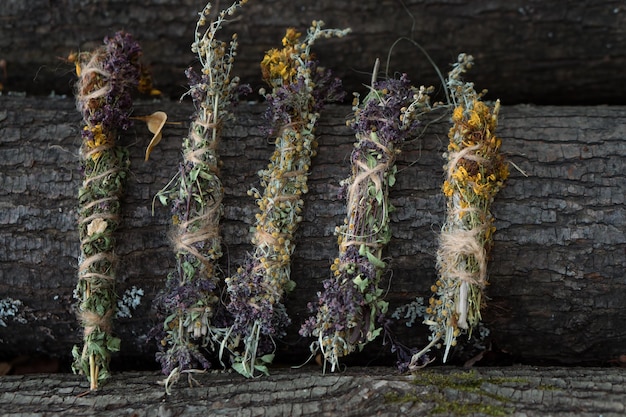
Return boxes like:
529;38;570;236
150;0;247;376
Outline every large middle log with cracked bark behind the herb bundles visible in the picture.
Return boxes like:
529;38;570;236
0;96;626;369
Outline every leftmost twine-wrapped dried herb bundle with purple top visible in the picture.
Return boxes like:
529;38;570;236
72;32;141;390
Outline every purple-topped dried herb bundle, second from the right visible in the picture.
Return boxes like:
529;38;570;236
300;71;430;371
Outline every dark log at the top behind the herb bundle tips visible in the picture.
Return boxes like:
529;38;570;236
0;0;626;104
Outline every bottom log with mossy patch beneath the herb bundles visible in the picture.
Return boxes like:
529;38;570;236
0;367;626;417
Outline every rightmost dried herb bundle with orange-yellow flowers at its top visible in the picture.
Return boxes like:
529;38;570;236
411;54;509;367
